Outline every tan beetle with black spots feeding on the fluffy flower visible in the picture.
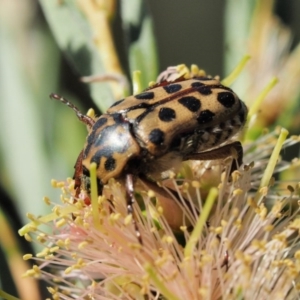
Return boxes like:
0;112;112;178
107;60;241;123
50;76;248;242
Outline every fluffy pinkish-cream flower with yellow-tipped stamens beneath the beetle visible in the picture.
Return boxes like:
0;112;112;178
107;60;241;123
20;63;300;300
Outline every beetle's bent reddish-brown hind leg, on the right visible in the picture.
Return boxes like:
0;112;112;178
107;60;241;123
185;141;243;173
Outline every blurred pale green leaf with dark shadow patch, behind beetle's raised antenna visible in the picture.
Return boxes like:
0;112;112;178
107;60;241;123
40;0;115;111
